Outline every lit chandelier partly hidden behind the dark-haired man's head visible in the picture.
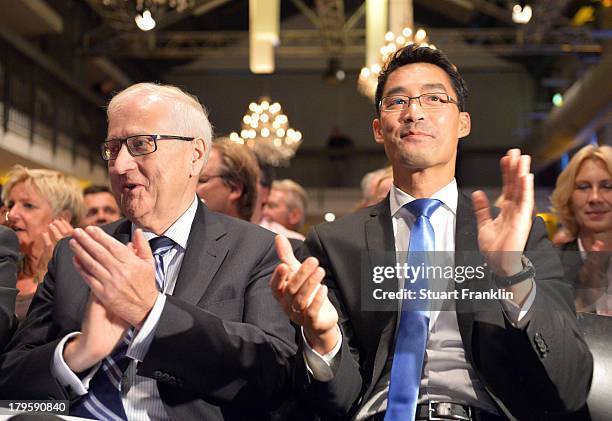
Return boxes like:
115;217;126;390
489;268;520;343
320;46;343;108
357;28;436;100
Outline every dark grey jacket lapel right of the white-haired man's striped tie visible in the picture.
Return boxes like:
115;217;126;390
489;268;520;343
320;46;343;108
173;203;228;305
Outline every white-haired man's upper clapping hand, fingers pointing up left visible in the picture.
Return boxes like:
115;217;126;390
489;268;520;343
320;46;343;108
70;226;159;329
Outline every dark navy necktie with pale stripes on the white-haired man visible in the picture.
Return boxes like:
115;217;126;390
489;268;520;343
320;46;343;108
70;237;174;421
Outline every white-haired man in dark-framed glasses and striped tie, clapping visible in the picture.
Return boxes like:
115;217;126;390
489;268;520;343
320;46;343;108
0;83;295;420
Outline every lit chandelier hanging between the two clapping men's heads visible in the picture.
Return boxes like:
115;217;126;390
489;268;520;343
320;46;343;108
229;97;302;166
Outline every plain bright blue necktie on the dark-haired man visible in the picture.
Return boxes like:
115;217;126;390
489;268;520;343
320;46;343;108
385;199;442;421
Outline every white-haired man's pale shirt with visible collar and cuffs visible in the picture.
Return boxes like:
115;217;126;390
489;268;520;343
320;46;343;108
51;197;198;421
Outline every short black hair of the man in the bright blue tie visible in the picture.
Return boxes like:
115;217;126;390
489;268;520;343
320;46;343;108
375;44;468;116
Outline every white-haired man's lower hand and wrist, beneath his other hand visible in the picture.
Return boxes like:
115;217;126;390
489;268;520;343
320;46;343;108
64;293;129;373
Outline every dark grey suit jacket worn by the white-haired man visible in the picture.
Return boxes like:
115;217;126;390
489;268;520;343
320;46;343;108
0;204;296;421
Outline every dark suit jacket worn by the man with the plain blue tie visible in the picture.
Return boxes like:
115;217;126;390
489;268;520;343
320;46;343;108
296;194;592;420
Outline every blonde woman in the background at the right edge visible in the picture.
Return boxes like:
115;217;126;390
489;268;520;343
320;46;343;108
551;145;612;315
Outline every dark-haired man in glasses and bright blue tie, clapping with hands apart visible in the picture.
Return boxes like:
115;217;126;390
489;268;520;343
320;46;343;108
270;45;593;421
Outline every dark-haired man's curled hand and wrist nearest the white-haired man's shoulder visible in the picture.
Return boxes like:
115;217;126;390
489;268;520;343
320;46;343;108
270;235;340;355
